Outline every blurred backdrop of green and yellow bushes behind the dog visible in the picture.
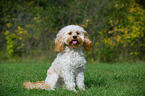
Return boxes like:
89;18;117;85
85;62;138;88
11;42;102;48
0;0;145;62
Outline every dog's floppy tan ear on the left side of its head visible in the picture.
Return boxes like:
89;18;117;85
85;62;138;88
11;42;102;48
55;36;64;52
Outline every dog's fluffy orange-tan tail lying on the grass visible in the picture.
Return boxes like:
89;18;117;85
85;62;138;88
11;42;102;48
23;81;49;89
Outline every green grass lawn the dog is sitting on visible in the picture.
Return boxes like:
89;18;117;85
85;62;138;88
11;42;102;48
0;61;145;96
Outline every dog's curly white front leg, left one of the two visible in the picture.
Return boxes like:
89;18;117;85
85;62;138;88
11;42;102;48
62;70;76;91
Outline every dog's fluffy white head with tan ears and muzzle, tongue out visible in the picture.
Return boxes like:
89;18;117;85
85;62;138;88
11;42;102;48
55;25;92;52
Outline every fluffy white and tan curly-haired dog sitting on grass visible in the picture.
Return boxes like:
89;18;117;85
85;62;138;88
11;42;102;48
23;25;92;91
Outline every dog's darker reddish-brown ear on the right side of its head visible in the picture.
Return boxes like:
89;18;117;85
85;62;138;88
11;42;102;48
83;31;93;51
